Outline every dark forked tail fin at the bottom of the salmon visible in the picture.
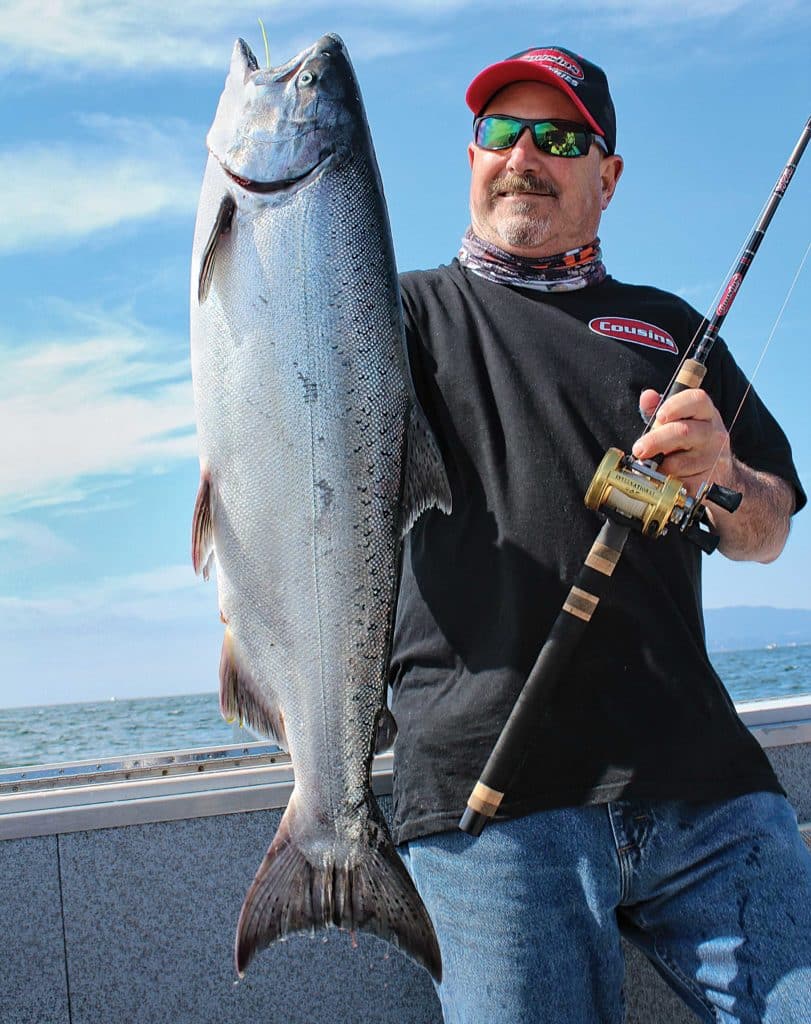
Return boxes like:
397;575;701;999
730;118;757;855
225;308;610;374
236;797;442;981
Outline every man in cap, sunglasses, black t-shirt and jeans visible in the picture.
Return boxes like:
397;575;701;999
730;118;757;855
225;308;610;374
392;46;811;1024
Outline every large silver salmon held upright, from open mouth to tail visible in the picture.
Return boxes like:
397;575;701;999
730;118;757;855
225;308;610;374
191;35;451;978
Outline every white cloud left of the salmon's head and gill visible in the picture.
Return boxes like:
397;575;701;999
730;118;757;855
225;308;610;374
0;116;205;252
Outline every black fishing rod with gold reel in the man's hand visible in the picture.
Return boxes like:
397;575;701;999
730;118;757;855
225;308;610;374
459;118;811;836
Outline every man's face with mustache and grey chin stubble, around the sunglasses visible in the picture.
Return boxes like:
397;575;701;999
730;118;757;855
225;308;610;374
468;82;623;256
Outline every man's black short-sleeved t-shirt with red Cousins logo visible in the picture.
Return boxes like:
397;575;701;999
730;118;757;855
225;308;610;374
391;261;805;842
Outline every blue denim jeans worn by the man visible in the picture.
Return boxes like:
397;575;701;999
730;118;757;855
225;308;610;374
400;793;811;1024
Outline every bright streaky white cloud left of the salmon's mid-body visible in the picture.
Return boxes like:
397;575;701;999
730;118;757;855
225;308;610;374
0;313;197;511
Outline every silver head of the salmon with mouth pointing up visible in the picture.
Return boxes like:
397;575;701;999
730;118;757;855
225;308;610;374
207;35;368;196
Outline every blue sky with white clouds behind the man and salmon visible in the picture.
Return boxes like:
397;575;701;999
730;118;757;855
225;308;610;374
0;0;811;706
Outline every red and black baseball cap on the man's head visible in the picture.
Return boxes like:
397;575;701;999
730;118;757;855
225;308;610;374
465;46;616;153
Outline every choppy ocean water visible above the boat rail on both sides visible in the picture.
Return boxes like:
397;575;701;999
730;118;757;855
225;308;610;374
0;644;811;768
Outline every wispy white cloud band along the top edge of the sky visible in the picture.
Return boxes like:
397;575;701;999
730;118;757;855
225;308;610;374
0;0;802;76
